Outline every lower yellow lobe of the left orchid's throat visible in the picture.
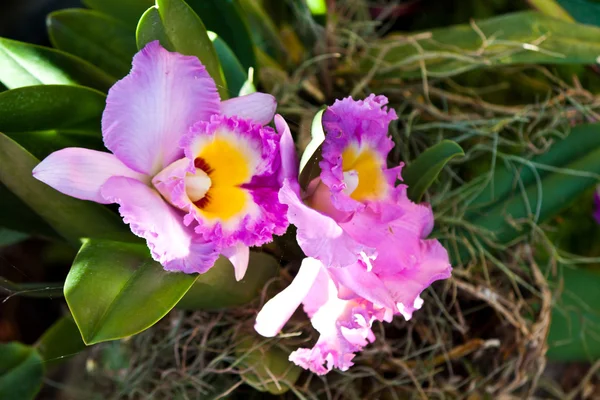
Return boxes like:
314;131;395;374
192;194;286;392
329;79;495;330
200;186;251;222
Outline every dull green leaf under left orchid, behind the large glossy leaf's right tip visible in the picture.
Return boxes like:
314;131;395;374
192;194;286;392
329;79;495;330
177;252;279;310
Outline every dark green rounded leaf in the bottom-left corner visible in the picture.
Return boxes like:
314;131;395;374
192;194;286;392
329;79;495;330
0;342;44;400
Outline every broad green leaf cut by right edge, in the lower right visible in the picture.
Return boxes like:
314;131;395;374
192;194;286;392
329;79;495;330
546;267;600;362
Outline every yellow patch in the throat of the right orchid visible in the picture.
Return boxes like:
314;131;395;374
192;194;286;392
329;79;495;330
342;146;387;201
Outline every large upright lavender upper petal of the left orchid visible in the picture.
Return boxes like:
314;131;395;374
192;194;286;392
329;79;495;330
102;41;220;176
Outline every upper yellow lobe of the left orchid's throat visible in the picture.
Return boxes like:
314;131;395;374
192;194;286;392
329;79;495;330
196;135;252;188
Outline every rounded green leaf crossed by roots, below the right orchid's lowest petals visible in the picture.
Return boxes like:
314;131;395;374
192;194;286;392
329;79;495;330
235;334;302;395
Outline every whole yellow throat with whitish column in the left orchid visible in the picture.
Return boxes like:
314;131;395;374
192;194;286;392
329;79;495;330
186;134;254;222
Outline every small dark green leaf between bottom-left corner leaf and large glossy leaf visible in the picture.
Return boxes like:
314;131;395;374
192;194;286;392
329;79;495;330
36;315;86;368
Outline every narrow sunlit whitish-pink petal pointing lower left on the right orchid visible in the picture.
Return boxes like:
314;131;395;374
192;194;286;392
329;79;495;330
254;258;323;337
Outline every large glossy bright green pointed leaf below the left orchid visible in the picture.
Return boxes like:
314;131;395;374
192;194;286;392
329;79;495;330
65;240;197;345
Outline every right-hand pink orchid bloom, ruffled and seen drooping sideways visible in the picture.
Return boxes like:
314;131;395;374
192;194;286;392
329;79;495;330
255;95;451;373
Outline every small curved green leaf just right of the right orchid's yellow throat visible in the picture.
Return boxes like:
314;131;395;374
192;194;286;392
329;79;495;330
402;140;465;203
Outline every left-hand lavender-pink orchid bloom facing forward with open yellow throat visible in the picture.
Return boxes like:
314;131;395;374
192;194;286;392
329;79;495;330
33;41;288;280
